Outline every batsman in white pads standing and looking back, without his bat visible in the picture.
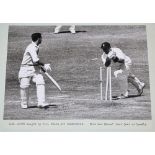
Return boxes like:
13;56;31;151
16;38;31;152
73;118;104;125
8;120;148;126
18;33;51;109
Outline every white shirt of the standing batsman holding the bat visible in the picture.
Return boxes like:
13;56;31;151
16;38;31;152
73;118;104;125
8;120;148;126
18;42;39;78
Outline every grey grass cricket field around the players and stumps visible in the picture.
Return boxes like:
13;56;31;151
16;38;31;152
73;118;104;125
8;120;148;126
4;26;151;120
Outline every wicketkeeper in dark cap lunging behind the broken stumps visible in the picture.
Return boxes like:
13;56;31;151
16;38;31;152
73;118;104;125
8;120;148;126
101;42;145;98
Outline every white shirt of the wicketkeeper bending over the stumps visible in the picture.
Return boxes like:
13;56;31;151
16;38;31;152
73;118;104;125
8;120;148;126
101;48;132;69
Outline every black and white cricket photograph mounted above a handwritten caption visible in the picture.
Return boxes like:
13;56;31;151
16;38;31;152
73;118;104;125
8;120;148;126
3;24;152;120
